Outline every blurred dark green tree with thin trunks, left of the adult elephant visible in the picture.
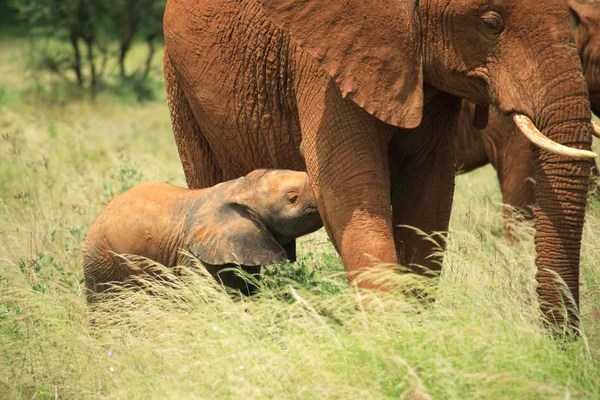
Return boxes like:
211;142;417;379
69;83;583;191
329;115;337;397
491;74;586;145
12;0;166;99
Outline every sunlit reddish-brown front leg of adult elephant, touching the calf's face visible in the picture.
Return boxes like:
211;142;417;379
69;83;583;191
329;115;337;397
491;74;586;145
298;78;396;288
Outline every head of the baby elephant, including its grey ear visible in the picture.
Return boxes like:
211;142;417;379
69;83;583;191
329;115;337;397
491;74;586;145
186;170;323;266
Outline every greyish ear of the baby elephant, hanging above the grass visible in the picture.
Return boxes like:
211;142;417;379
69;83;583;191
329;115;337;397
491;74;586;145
186;202;286;266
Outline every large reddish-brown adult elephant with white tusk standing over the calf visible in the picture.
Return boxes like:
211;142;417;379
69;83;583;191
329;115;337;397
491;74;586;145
164;0;592;332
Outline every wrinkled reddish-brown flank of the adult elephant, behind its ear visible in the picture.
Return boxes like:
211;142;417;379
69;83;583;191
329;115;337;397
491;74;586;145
165;1;305;179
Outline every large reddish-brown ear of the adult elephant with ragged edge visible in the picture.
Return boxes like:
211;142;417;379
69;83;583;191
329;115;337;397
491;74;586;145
259;0;423;128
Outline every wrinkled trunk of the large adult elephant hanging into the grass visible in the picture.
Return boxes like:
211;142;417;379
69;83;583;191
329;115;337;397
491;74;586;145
534;83;592;330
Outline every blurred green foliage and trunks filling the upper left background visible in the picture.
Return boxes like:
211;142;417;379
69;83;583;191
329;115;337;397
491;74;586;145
0;0;166;101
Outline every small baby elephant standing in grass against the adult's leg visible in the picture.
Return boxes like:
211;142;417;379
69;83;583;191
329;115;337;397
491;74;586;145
83;170;323;302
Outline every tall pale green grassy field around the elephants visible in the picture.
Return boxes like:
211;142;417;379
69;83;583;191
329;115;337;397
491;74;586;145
0;36;600;399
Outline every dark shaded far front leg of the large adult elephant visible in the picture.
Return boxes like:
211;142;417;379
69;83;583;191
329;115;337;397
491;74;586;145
390;94;460;276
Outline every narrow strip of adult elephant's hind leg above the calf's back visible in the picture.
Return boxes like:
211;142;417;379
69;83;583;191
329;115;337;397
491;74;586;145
164;51;224;189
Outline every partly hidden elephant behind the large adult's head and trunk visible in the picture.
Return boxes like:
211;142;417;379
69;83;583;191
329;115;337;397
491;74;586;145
456;0;600;240
